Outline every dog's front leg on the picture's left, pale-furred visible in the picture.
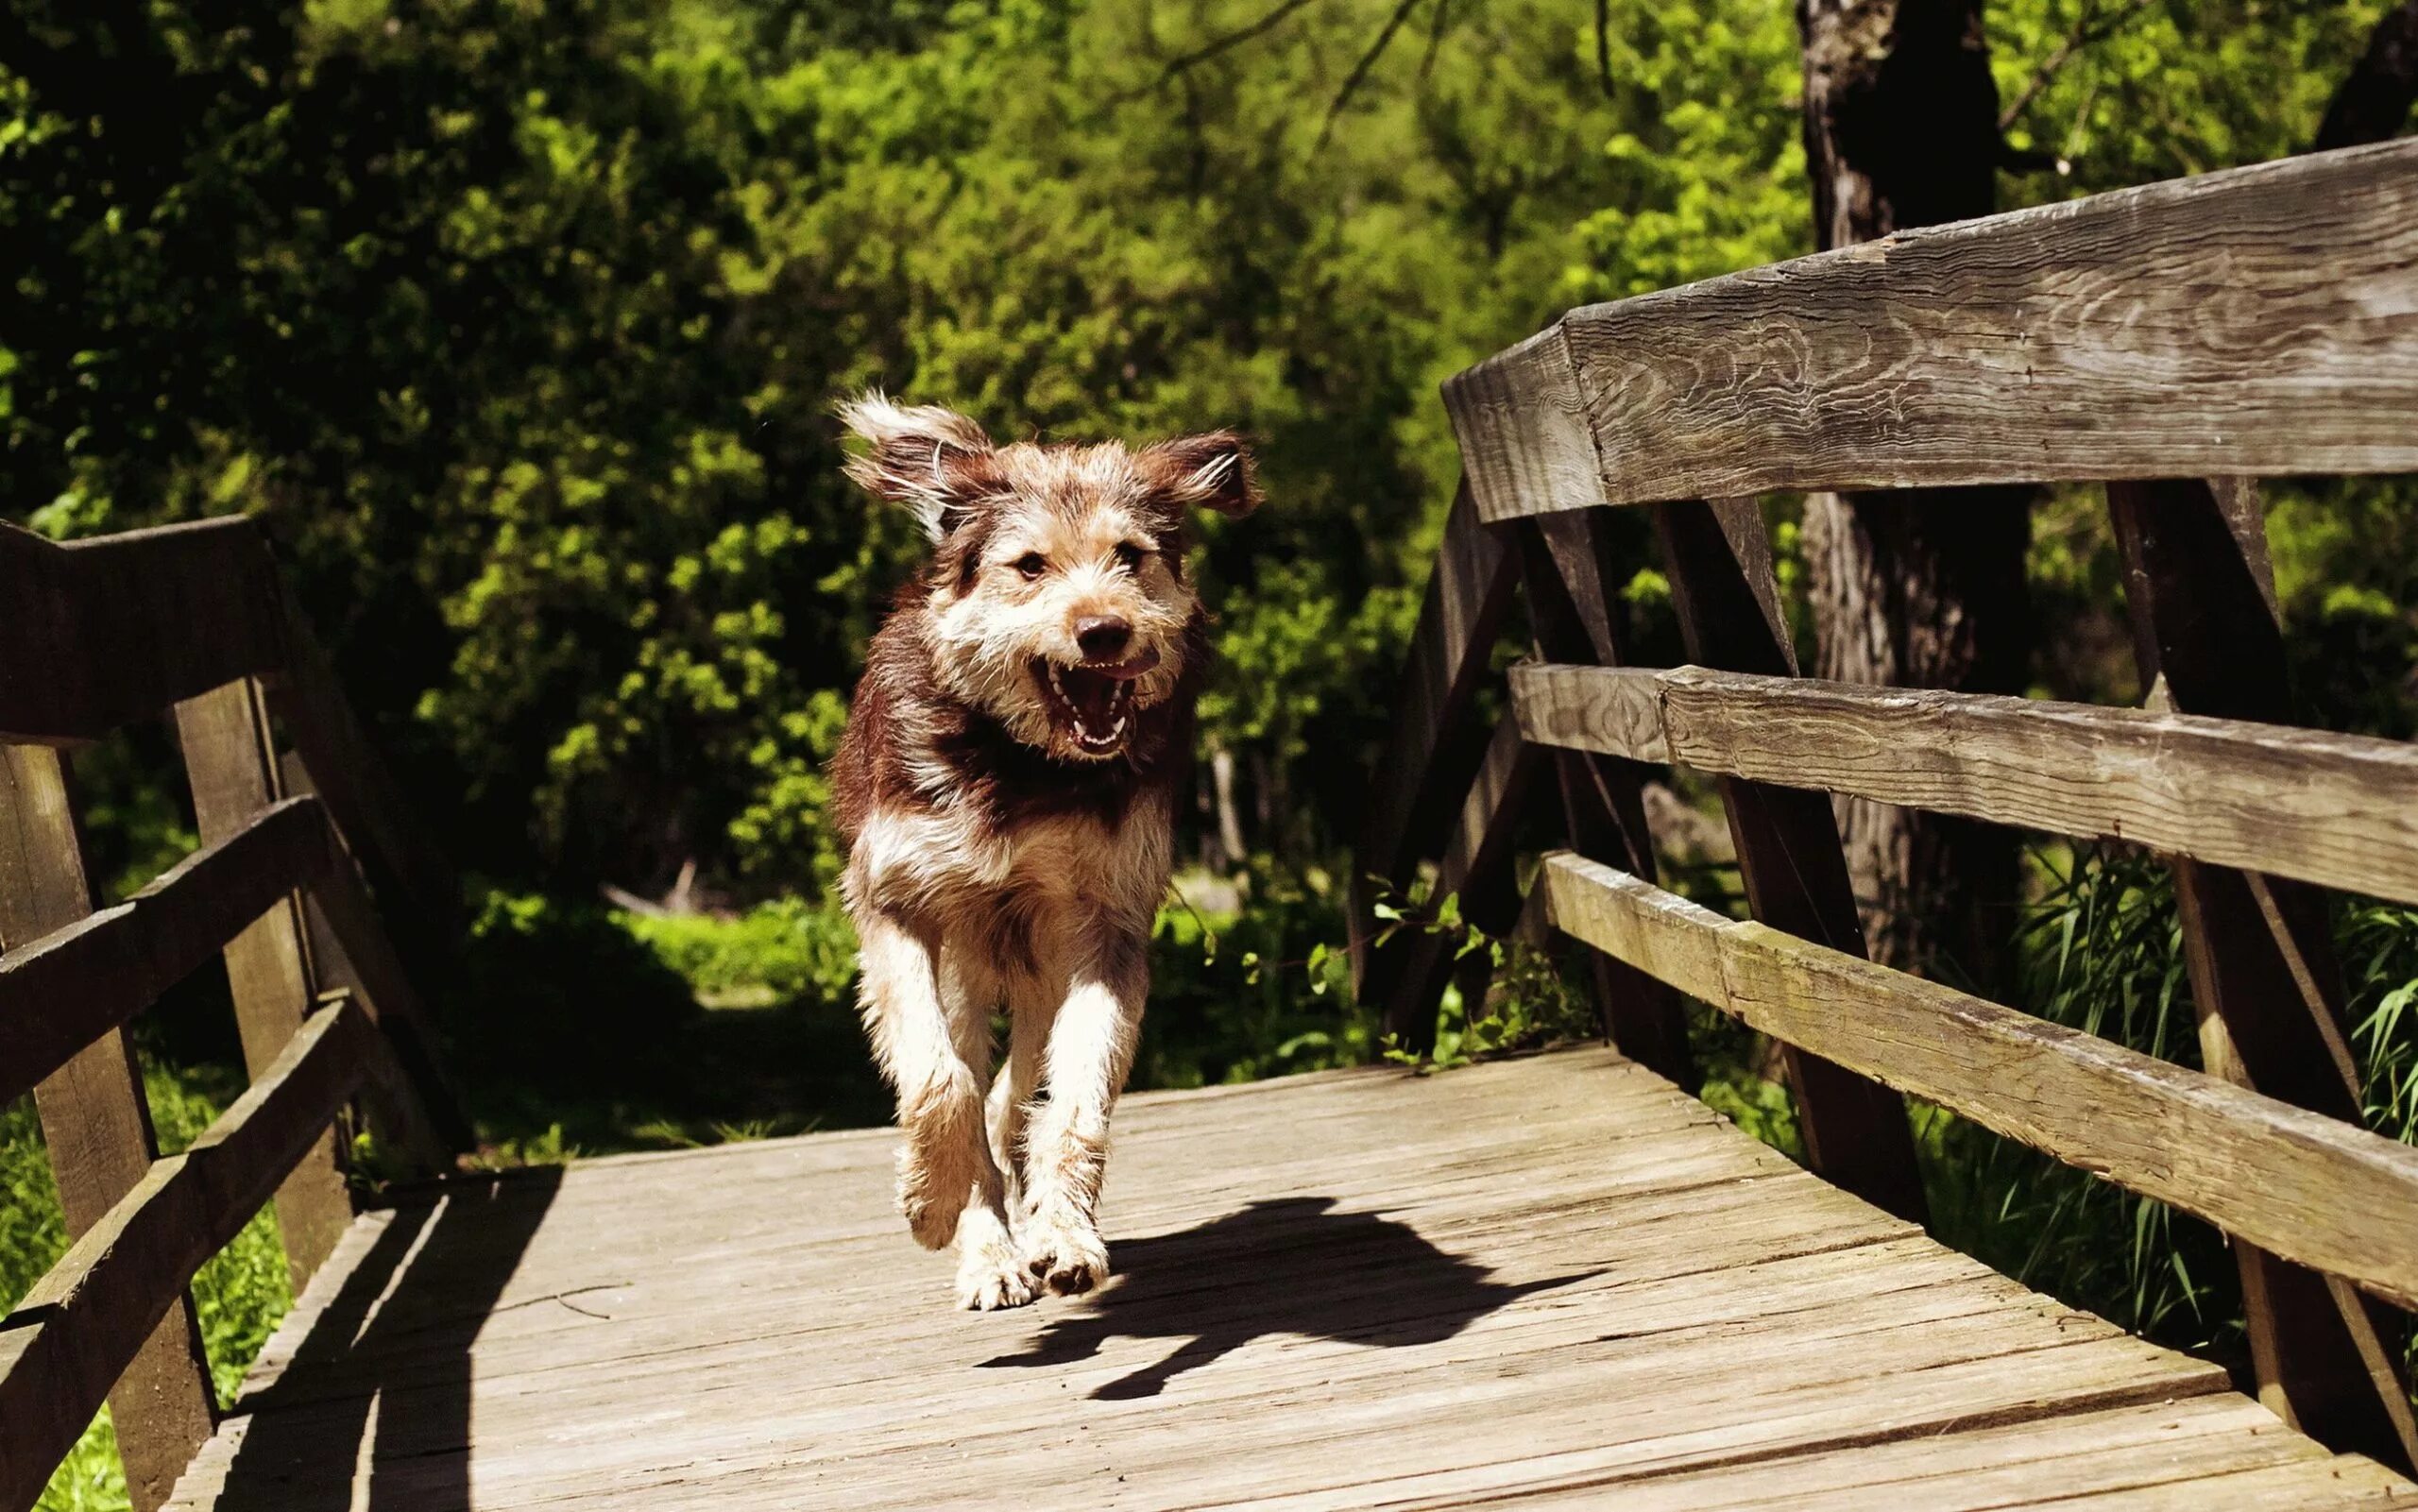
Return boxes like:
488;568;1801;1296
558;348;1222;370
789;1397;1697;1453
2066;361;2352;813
859;912;1037;1309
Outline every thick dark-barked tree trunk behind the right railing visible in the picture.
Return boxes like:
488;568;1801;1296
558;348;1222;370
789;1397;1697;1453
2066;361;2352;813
1796;0;2031;987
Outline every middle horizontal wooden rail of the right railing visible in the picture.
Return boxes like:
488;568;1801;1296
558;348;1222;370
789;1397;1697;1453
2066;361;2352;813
1511;663;2418;902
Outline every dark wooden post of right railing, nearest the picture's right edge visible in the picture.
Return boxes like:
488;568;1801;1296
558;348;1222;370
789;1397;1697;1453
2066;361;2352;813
2108;479;2418;1470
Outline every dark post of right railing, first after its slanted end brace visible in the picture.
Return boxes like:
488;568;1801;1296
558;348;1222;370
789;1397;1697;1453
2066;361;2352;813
1511;505;1697;1091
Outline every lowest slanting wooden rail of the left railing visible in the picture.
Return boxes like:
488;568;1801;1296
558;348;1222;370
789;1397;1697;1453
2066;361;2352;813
0;1004;375;1507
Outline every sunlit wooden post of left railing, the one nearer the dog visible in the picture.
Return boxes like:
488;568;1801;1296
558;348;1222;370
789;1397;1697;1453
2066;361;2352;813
177;677;353;1292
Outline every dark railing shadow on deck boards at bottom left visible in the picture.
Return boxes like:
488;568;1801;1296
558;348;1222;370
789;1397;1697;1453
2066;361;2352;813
208;1166;563;1512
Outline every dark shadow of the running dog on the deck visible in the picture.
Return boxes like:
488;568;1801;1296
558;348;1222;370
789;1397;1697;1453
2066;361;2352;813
981;1198;1586;1401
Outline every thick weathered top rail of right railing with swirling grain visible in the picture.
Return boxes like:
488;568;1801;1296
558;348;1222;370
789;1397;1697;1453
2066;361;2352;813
1446;141;2418;520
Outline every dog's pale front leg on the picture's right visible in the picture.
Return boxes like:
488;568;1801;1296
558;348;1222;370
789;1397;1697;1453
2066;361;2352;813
1023;929;1151;1297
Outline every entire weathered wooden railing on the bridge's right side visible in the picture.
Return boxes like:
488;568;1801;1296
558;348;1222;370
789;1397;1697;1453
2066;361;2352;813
1354;143;2418;1469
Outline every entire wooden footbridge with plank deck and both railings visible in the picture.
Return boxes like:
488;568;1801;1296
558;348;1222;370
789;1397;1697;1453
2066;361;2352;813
0;143;2418;1512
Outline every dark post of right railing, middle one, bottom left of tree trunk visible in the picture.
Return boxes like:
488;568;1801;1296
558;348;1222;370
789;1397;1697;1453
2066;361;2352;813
1651;499;1925;1222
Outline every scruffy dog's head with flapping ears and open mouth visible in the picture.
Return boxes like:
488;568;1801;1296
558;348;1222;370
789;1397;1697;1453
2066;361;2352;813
839;392;1260;762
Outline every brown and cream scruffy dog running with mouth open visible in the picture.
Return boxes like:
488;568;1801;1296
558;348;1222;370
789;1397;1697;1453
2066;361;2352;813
832;395;1260;1309
